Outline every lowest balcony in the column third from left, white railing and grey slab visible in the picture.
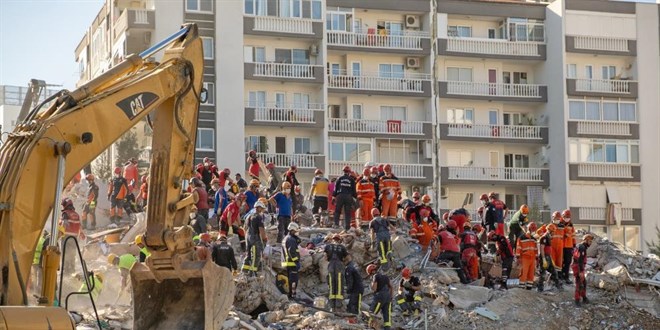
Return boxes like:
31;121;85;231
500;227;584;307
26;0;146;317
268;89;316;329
440;166;550;186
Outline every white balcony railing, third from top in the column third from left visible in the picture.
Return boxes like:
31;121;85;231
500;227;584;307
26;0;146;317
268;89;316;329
447;124;543;140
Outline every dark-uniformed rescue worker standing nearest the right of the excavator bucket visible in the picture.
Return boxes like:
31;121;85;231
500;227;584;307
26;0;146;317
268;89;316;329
243;201;268;276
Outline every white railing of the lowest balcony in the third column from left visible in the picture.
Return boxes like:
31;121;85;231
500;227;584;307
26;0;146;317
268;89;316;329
448;166;543;182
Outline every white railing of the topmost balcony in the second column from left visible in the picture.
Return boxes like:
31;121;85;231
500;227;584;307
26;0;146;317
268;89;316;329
328;31;429;49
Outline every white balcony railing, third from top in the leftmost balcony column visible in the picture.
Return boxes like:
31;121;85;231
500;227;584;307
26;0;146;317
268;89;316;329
245;102;324;124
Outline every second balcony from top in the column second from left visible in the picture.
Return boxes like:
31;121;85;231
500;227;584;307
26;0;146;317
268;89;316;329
328;70;431;97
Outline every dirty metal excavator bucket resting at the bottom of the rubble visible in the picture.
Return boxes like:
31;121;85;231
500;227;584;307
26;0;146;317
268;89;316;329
131;261;236;330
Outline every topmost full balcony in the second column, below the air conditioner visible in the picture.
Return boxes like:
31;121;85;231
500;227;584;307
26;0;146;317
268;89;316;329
328;29;431;56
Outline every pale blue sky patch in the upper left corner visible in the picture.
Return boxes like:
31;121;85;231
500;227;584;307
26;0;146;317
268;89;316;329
0;0;104;90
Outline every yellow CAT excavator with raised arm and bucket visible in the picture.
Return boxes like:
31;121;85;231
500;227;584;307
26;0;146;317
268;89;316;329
0;24;235;330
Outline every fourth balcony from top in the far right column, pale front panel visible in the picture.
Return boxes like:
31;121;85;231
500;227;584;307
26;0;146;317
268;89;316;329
568;163;641;182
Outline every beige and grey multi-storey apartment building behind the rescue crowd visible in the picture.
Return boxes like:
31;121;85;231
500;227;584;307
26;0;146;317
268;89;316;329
76;0;660;250
